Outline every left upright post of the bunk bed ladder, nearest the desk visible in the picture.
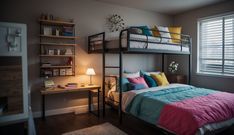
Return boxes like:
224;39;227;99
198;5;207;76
102;33;106;117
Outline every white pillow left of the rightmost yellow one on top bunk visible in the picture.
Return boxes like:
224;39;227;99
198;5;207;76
157;26;171;43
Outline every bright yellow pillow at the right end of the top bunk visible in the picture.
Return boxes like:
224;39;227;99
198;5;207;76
168;27;182;43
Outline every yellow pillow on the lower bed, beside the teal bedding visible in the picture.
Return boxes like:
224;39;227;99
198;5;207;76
150;72;169;86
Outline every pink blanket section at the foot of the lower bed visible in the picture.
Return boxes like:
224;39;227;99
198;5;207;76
159;92;234;135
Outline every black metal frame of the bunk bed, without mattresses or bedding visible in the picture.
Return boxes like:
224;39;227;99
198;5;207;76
88;27;192;134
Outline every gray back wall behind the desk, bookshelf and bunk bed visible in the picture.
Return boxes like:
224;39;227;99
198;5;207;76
0;0;173;111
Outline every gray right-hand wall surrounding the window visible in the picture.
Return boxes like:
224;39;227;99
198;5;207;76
168;1;234;92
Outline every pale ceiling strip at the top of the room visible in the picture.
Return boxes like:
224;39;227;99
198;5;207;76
96;0;229;15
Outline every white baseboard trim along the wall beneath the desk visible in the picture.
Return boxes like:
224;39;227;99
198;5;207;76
33;104;97;118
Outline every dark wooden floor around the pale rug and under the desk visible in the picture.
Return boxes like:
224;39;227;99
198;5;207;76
36;110;234;135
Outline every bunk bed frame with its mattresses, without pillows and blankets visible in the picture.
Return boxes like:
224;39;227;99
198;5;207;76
88;28;234;134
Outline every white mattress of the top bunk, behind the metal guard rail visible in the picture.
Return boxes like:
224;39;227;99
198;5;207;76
88;34;189;52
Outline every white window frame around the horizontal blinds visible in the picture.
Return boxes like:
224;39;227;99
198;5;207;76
196;12;234;78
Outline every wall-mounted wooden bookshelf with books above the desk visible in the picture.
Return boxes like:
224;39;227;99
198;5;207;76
38;19;78;77
